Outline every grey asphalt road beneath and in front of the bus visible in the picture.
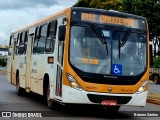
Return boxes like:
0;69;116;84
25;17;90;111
0;75;160;120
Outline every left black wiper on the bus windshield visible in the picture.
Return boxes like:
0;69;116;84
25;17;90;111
90;24;108;55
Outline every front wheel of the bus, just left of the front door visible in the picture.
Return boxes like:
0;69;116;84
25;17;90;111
46;85;57;109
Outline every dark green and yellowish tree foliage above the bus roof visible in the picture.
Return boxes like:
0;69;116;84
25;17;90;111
74;0;160;39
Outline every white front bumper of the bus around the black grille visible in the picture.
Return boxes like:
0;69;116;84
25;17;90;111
62;85;148;107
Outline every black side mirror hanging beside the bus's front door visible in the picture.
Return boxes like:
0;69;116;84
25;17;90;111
58;25;66;41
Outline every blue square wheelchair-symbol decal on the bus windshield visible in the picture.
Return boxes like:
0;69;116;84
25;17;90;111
112;64;122;75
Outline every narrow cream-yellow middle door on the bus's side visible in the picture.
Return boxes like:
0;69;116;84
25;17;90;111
25;29;34;92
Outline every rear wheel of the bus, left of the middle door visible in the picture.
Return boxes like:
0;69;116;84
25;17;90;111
16;75;25;96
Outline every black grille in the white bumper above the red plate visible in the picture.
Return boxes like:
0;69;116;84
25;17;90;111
87;94;132;104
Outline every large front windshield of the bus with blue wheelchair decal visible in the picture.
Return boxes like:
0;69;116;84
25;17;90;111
70;25;147;76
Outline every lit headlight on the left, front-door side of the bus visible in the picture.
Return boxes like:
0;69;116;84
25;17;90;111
66;73;82;90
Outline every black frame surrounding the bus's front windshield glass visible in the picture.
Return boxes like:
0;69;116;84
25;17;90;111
68;22;148;84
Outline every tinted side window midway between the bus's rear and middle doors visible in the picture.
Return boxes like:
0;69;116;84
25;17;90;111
18;32;25;54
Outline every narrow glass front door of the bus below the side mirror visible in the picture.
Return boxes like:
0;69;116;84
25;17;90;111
55;17;65;99
